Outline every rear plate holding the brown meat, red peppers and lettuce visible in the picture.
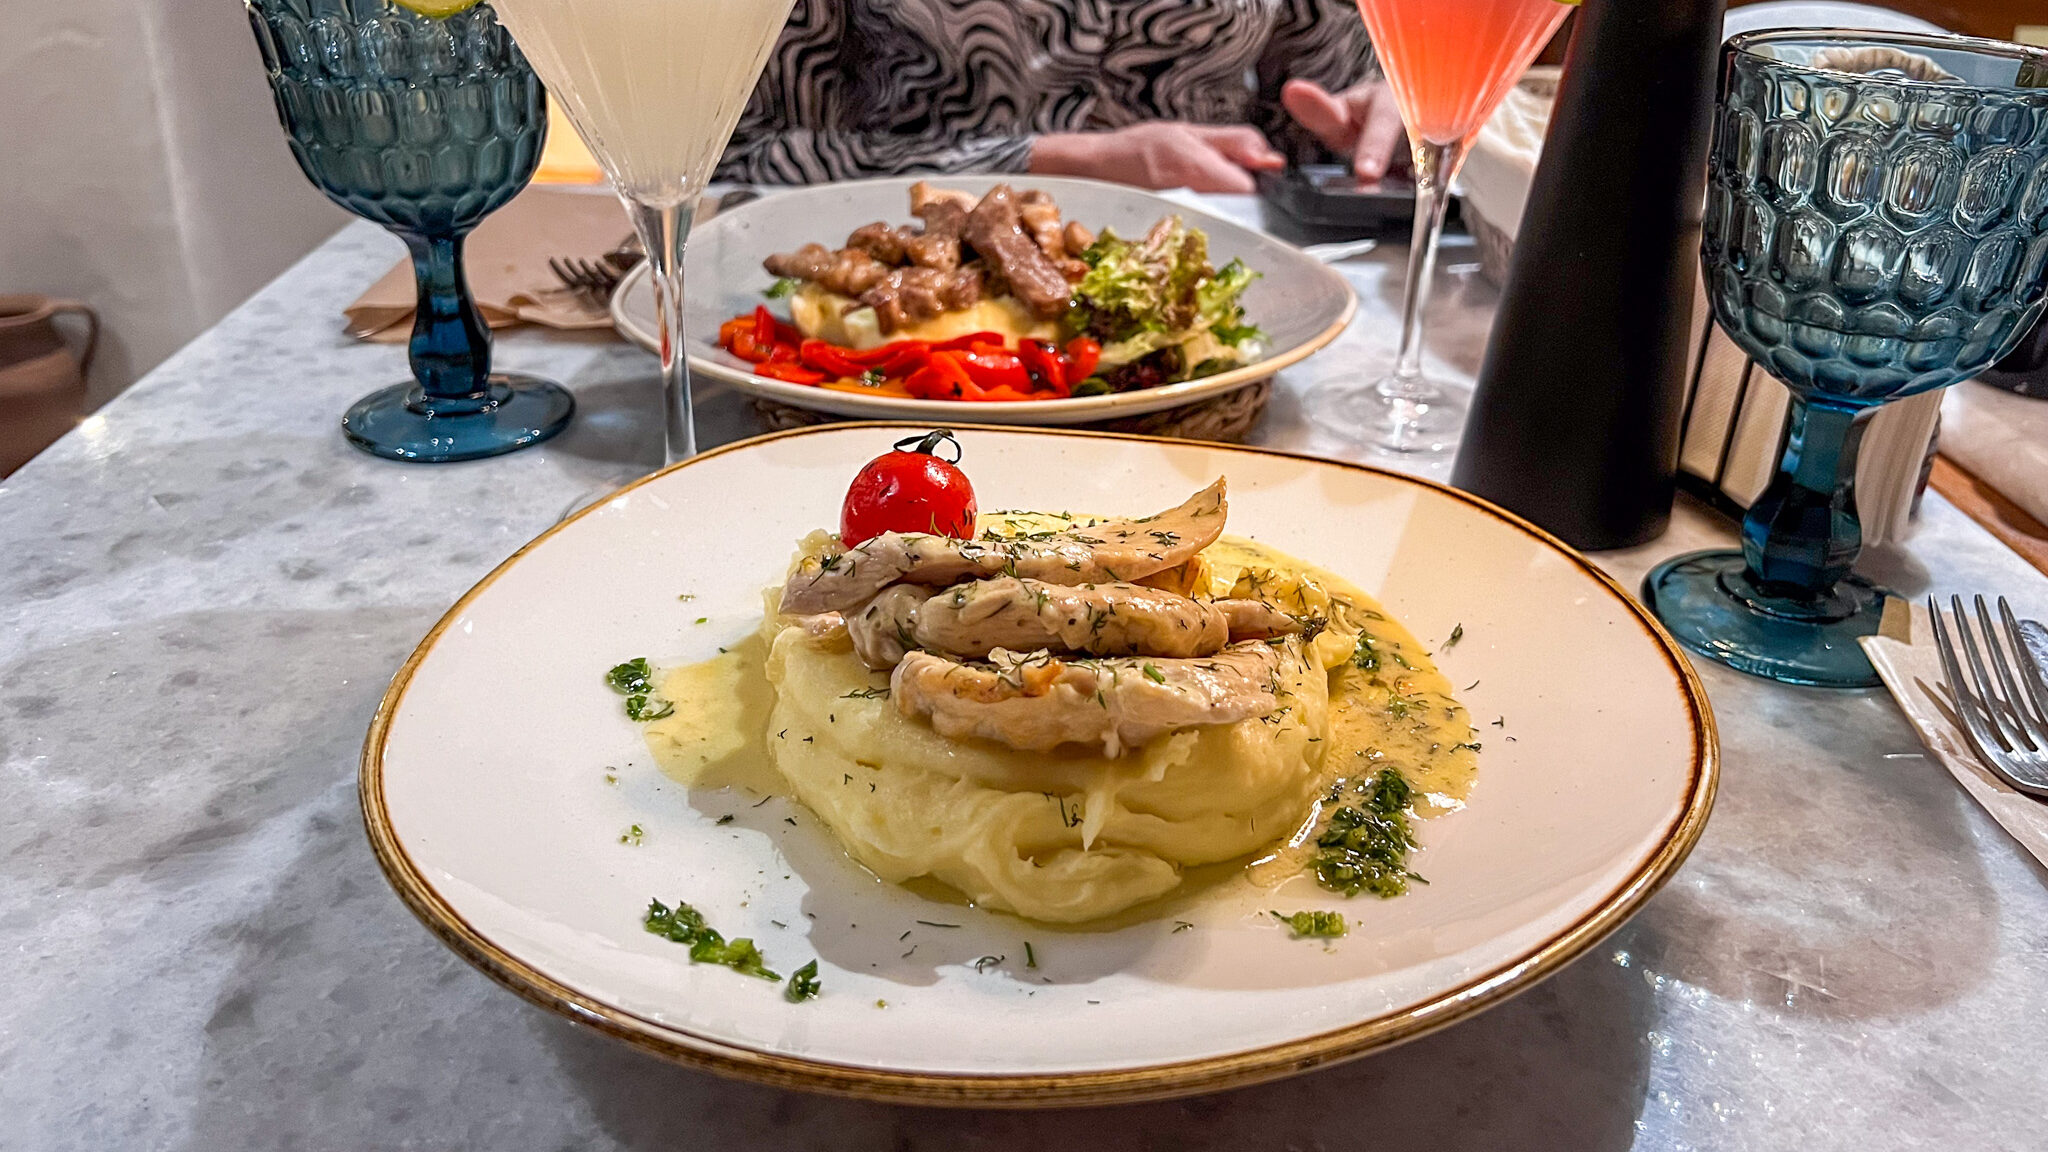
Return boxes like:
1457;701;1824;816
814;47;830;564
612;176;1358;424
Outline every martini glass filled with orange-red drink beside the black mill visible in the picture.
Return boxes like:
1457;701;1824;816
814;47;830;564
1319;0;1571;453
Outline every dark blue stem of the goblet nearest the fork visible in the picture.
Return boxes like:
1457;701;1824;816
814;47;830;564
1743;398;1876;603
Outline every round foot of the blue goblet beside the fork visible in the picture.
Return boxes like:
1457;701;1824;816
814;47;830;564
1642;551;1886;689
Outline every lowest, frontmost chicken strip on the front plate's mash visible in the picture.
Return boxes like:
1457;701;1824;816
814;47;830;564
889;640;1284;756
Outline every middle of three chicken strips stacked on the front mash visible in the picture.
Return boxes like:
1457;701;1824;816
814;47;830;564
848;576;1300;668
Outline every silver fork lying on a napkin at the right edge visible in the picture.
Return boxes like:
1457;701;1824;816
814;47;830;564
1927;596;2048;799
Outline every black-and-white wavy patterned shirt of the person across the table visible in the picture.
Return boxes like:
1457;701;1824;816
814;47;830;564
717;0;1372;184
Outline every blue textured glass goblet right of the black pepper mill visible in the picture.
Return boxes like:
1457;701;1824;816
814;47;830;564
1642;31;2048;687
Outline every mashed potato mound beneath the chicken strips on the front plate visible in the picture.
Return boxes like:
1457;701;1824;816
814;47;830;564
764;537;1370;922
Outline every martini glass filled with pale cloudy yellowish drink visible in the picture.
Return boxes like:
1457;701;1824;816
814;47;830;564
494;0;793;463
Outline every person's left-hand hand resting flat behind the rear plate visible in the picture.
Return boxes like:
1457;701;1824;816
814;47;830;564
1030;121;1286;193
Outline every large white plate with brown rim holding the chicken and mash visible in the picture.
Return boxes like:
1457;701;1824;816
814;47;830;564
362;424;1716;1105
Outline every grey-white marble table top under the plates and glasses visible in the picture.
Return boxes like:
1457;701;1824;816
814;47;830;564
0;203;2048;1152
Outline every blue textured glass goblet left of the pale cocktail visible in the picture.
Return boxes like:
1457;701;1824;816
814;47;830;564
246;0;575;461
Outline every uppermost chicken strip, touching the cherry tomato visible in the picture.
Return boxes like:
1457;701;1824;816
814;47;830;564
782;480;1229;615
